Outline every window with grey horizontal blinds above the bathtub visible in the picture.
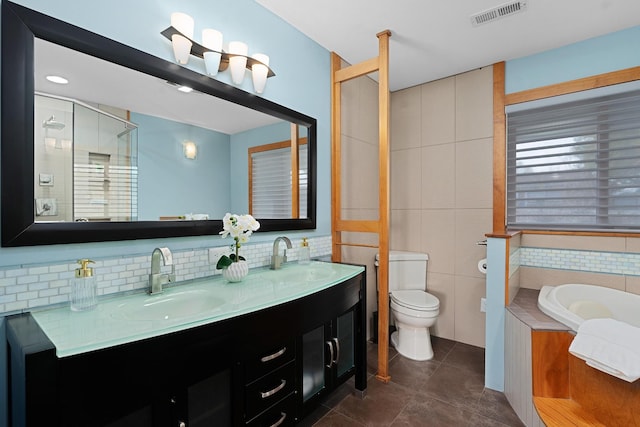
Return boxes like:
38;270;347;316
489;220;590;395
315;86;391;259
506;83;640;231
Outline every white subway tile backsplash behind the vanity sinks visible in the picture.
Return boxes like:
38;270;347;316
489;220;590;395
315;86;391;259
0;236;331;315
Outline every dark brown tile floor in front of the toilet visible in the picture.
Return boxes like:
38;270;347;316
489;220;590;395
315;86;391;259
301;337;524;427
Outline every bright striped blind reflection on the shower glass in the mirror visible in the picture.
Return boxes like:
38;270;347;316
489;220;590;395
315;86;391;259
73;153;138;221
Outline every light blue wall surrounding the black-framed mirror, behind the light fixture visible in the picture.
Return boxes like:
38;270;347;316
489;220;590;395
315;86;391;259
0;0;331;267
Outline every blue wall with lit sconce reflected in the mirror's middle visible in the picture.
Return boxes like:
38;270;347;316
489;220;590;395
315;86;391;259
131;113;232;221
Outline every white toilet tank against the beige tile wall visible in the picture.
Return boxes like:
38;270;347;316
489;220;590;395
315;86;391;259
376;251;429;292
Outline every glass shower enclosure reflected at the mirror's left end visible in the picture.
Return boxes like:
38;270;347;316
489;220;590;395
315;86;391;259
34;94;138;222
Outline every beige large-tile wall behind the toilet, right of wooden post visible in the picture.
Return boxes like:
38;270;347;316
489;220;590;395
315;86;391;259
390;67;493;346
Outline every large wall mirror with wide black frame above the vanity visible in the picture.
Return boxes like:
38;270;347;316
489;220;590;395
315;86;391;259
1;1;316;246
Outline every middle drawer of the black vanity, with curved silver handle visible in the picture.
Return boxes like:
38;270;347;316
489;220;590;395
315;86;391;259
245;361;296;419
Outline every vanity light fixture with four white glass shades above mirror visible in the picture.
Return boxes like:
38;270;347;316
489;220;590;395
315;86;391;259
160;17;275;93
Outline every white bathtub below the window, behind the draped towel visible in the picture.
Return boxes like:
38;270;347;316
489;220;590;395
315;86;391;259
538;284;640;332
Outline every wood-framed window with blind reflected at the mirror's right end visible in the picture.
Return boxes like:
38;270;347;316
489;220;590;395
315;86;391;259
249;138;308;219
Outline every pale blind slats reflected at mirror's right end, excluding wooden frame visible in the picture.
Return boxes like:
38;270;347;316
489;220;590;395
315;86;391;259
251;144;308;218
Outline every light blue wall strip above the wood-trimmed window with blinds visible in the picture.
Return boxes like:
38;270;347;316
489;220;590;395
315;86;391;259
505;26;640;93
